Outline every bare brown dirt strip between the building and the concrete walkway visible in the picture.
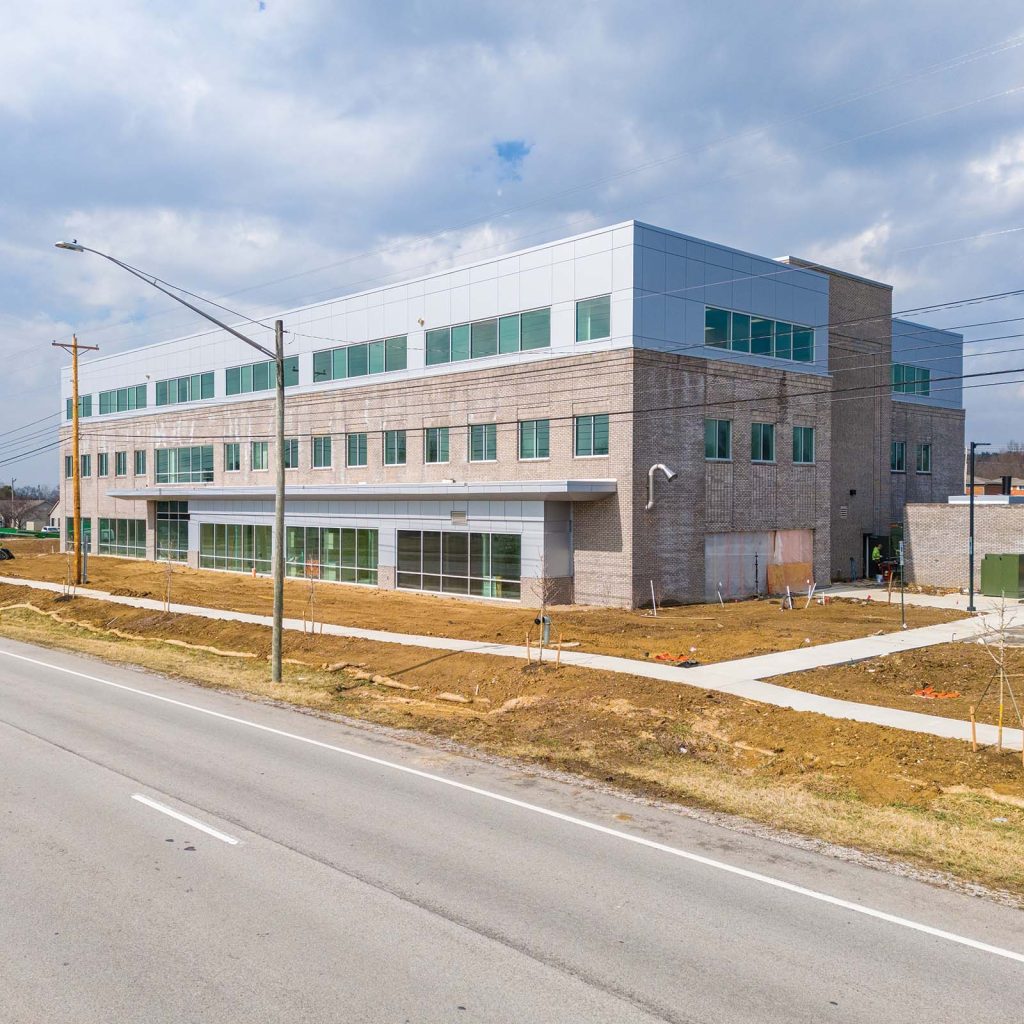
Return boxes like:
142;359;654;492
0;540;964;665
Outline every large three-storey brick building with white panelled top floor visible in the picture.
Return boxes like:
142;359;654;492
61;221;964;606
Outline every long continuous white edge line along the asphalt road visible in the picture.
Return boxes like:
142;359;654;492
0;649;1024;964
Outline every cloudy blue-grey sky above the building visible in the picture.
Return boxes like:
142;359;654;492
0;0;1024;484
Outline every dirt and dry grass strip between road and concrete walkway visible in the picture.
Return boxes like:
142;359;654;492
0;578;1024;896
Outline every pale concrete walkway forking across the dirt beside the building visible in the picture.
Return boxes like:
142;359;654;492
0;577;1024;750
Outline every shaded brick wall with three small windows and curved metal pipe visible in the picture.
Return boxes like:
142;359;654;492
633;351;831;604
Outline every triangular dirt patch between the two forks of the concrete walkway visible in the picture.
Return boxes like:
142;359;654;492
772;643;1024;728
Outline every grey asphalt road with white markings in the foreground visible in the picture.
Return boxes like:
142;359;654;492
0;640;1024;1024
